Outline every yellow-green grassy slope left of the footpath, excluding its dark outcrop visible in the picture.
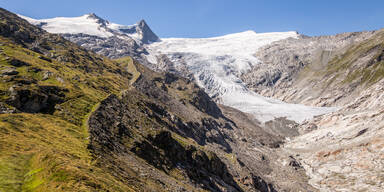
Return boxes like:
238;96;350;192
0;33;140;192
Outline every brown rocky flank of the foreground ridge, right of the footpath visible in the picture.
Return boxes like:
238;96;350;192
88;60;313;191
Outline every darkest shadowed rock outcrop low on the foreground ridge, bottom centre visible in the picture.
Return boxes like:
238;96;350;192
131;131;242;191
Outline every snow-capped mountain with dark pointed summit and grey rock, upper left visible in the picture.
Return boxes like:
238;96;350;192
19;13;159;64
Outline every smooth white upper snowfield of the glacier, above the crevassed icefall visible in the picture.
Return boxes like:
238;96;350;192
150;31;299;72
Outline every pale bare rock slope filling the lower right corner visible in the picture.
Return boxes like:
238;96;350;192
284;80;384;191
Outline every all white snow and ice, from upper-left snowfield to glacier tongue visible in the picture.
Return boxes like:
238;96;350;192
19;14;337;123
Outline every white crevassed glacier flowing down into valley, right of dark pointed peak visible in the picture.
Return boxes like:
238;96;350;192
147;31;336;123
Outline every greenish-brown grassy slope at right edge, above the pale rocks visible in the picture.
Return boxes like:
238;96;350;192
299;30;384;87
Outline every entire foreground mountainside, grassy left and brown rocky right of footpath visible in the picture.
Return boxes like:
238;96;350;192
0;9;315;191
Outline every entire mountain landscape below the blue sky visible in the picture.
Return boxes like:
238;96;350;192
7;8;384;191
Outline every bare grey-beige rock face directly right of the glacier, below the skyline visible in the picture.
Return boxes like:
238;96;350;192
241;32;376;106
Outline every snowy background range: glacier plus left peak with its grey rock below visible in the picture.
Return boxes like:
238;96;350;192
20;15;336;122
